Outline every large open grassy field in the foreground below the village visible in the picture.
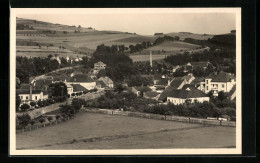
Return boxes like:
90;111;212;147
16;113;236;150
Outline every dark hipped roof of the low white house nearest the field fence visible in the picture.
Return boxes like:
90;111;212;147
167;89;207;99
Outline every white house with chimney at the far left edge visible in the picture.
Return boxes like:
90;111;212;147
16;85;49;104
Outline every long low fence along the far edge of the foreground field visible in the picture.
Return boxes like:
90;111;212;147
84;108;236;127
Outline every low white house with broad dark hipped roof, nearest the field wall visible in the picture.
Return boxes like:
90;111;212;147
167;87;210;105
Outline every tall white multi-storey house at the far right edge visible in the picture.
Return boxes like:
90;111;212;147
199;72;236;96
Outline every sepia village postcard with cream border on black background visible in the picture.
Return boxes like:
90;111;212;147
10;8;242;155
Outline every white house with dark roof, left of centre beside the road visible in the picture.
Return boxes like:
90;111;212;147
66;74;96;90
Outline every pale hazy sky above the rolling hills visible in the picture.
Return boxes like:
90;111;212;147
17;13;236;35
